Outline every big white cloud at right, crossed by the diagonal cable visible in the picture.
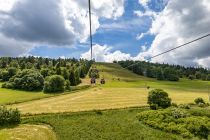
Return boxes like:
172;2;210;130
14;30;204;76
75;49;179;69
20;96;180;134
140;0;210;66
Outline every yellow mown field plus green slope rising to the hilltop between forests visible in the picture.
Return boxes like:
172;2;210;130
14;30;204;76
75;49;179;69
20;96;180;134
9;63;208;114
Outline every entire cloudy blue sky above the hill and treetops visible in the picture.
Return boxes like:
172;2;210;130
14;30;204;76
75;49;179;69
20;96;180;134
0;0;210;67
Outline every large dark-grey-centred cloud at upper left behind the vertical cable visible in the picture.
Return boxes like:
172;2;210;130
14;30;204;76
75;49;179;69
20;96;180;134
0;0;124;56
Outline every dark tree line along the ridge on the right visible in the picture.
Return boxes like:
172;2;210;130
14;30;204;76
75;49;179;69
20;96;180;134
115;60;210;81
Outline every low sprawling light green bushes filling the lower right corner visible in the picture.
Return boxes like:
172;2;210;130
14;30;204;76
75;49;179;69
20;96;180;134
137;108;210;139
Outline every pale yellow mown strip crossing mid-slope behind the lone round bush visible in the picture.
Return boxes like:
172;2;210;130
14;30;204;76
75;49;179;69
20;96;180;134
10;88;208;114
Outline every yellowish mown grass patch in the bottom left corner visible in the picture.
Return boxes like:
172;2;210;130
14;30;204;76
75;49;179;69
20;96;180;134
0;124;56;140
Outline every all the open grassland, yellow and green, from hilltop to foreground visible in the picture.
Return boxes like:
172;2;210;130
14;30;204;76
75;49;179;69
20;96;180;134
0;63;210;140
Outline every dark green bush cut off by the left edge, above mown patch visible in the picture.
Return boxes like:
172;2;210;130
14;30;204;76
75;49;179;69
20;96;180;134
0;106;20;126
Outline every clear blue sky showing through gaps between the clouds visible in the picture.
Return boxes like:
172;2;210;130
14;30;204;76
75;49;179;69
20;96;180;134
30;0;159;58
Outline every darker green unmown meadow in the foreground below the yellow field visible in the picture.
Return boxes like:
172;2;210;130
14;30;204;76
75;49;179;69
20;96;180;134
23;108;182;140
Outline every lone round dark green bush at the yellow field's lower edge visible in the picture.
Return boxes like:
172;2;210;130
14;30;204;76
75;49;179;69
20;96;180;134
148;89;171;109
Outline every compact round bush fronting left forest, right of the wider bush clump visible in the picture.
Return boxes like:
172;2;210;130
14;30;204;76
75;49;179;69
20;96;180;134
44;75;65;93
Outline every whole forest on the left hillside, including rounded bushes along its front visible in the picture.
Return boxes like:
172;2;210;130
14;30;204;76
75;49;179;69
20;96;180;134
0;56;92;92
